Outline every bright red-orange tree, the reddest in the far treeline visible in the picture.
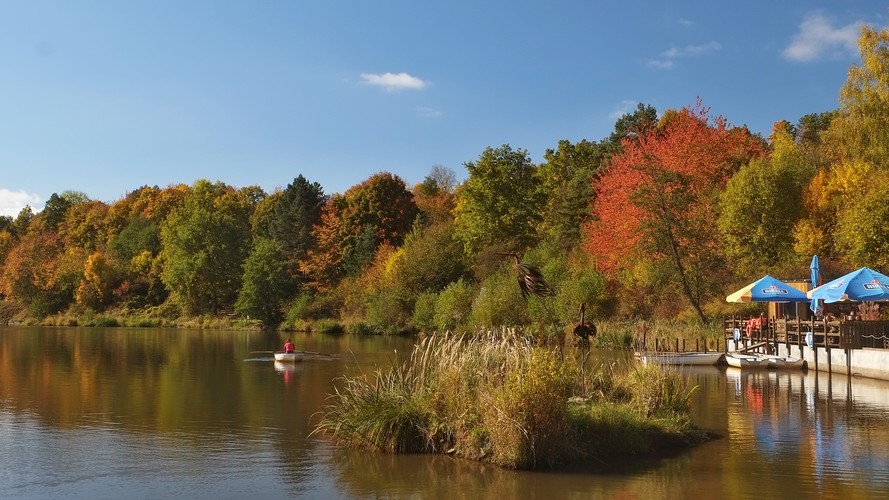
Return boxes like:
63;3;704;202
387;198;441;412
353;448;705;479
584;100;765;320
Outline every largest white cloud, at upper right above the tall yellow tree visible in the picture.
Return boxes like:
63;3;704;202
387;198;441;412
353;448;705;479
782;12;863;61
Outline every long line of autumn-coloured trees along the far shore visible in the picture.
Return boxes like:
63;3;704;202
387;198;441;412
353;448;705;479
0;26;889;333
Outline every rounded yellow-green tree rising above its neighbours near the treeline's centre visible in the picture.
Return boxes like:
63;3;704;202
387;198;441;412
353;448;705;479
454;145;546;256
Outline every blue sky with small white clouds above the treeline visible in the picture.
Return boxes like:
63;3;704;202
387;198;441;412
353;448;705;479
0;0;889;216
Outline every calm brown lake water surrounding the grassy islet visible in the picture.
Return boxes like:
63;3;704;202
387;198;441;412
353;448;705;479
0;327;889;499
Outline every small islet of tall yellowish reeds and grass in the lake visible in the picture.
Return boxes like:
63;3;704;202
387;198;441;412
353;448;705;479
315;335;708;469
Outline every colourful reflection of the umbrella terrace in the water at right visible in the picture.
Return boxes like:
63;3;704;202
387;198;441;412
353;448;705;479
725;368;889;496
